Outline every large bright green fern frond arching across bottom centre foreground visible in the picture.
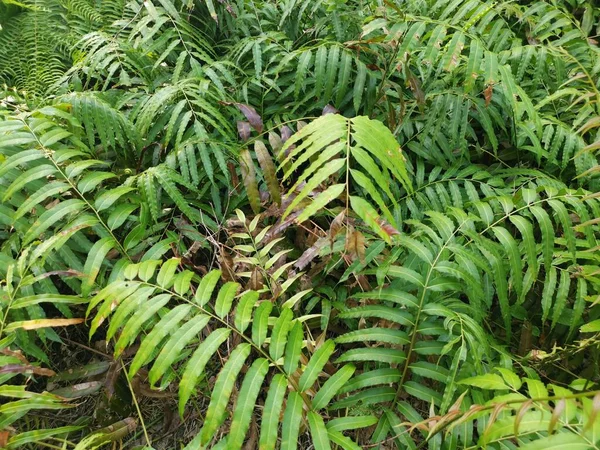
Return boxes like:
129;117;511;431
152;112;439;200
89;259;370;449
